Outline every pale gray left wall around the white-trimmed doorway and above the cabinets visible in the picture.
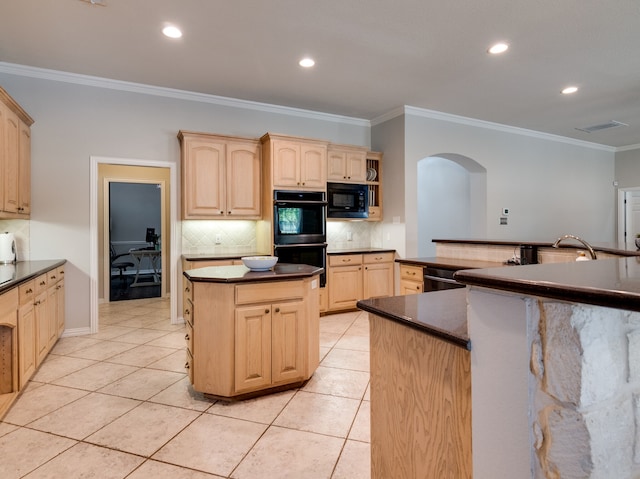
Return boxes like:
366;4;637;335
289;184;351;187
0;71;370;329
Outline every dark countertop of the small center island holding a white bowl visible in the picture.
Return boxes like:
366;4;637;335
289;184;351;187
182;263;322;283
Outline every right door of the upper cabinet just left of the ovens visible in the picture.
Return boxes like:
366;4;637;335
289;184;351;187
226;143;261;218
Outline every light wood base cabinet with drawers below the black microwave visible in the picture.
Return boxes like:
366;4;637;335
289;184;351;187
327;252;395;311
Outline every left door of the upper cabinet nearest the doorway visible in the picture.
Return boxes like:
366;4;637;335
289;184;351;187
182;138;226;219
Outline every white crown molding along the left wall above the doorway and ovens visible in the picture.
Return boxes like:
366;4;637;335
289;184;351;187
0;62;371;127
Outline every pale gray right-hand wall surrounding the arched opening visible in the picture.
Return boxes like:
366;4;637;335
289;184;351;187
388;110;616;257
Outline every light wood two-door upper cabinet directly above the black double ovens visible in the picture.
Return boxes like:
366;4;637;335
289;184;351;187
261;133;327;191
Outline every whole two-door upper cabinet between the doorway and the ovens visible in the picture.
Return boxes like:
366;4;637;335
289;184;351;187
178;131;261;219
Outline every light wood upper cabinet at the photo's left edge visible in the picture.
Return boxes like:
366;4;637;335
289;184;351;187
0;87;33;219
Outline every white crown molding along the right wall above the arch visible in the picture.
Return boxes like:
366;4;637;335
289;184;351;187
371;105;616;153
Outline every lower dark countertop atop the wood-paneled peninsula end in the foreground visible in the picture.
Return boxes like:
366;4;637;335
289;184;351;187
357;289;471;349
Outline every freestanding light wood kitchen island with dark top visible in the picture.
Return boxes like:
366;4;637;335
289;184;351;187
183;264;322;400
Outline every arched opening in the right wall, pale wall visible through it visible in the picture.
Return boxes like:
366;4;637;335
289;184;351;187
417;153;487;257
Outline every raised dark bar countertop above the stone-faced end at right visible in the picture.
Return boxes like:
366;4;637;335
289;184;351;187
454;256;640;311
